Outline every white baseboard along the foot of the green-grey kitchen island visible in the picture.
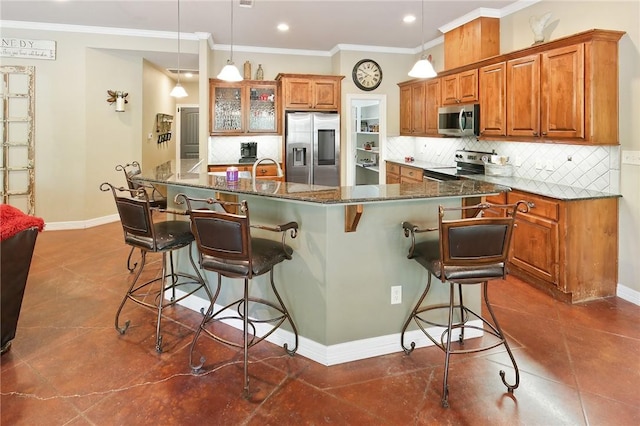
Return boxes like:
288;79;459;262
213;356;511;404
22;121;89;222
170;290;482;366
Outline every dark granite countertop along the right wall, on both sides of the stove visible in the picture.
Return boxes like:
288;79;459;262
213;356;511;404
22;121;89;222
386;159;621;201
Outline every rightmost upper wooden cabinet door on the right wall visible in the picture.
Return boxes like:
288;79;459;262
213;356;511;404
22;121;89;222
541;44;584;138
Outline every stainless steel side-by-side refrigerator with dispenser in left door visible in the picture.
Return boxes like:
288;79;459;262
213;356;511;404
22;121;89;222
285;112;340;186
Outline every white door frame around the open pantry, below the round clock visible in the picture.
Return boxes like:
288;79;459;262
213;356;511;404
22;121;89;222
343;93;387;186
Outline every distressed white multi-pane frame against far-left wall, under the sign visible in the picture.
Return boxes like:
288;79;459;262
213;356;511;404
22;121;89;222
0;66;35;215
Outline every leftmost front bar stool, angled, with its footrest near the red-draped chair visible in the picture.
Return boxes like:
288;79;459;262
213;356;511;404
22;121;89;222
100;182;213;353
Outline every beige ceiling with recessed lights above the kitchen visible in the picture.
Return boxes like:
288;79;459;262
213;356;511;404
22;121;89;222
0;0;524;69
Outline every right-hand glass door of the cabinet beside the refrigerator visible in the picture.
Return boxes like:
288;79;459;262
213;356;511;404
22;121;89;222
246;84;278;133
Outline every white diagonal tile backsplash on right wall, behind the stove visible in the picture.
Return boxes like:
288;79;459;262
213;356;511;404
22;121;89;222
385;136;620;194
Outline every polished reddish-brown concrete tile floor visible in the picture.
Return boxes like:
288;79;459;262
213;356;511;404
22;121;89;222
0;223;640;426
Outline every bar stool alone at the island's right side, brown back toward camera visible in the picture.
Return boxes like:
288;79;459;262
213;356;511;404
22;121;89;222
400;203;526;408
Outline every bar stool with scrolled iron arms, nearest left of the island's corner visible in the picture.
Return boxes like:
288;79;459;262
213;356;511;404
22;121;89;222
175;194;298;398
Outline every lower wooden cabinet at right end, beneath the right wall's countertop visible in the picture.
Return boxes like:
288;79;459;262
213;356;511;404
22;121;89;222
486;190;618;303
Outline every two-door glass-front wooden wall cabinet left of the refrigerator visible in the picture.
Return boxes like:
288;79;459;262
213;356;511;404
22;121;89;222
209;79;279;135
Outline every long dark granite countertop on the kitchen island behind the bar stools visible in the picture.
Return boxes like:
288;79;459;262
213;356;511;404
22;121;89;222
133;167;509;205
